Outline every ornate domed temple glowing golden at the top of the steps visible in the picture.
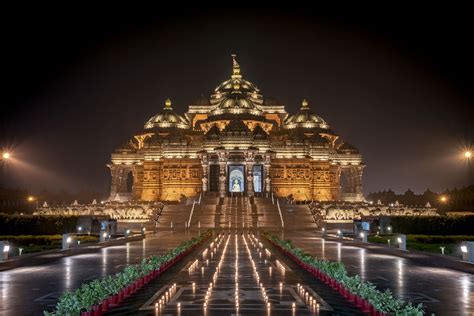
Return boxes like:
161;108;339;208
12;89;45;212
107;55;364;201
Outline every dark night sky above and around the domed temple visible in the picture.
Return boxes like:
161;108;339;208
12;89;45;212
0;7;474;195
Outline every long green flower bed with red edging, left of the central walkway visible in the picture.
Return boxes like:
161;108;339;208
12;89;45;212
44;231;211;316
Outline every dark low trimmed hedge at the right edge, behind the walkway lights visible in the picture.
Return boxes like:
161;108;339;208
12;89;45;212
390;216;474;235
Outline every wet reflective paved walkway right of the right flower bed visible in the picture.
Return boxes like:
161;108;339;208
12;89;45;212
280;231;474;316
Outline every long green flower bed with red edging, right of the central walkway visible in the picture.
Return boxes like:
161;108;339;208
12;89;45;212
263;233;424;316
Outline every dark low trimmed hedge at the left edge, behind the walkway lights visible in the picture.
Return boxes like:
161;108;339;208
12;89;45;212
0;214;79;235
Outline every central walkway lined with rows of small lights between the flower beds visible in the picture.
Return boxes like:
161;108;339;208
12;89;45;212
109;231;361;315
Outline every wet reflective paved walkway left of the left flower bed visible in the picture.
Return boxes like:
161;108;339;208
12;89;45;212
0;231;197;316
